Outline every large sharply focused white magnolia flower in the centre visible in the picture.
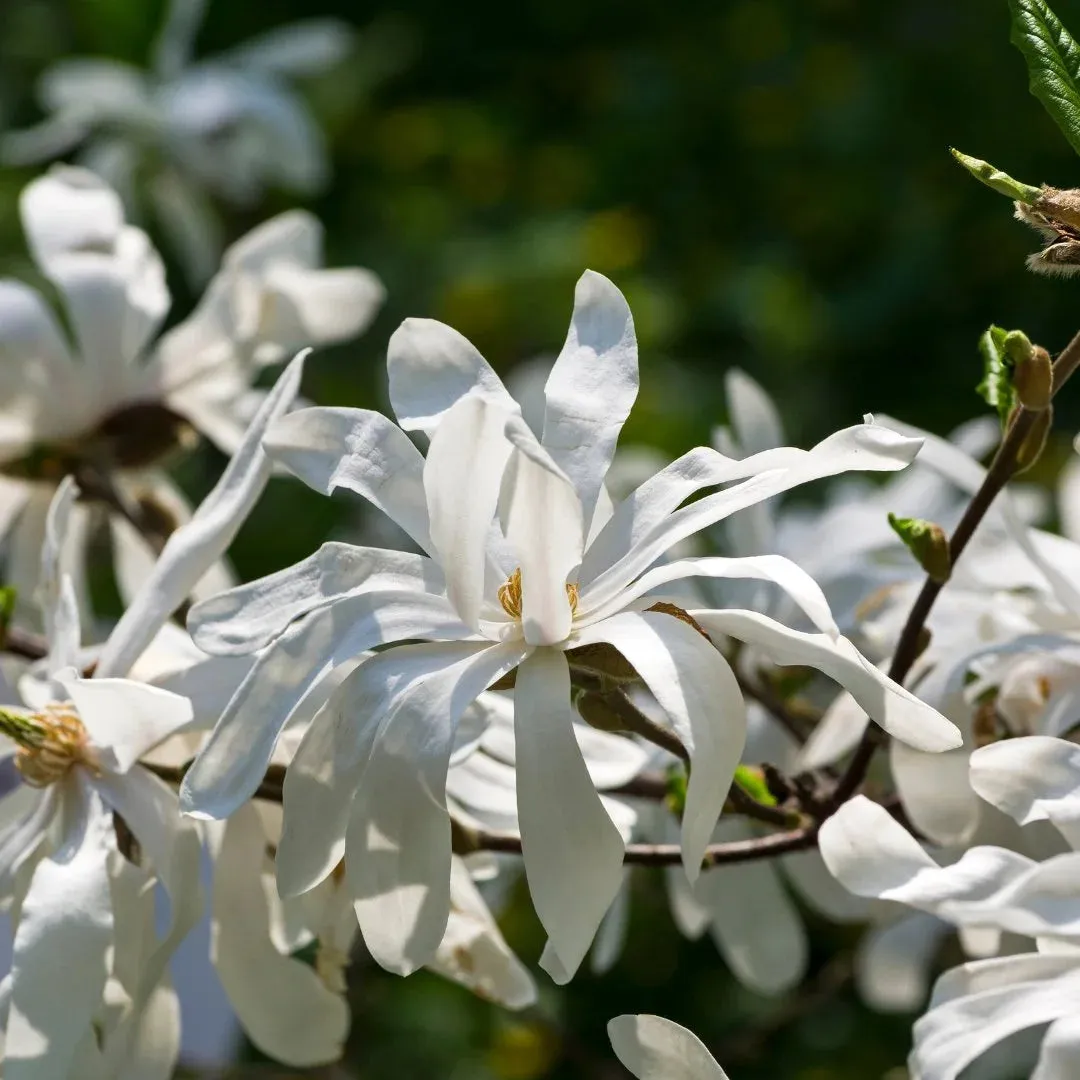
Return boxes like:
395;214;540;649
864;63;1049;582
183;273;958;981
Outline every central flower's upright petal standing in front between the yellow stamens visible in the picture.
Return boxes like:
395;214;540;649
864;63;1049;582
501;416;584;645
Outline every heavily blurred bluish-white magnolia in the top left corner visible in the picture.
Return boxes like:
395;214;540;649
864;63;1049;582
0;0;351;283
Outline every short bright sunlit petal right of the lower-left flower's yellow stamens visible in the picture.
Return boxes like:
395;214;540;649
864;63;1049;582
59;676;193;772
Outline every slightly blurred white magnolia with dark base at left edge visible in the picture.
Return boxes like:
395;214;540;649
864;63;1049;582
0;168;381;626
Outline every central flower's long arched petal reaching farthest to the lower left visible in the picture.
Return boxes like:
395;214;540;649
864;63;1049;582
180;592;469;818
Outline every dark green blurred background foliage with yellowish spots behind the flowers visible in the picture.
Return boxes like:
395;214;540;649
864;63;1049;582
0;0;1080;1080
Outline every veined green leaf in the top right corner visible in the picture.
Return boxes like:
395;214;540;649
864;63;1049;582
1009;0;1080;153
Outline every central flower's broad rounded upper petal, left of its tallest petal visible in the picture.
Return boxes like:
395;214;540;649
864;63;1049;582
387;319;517;435
